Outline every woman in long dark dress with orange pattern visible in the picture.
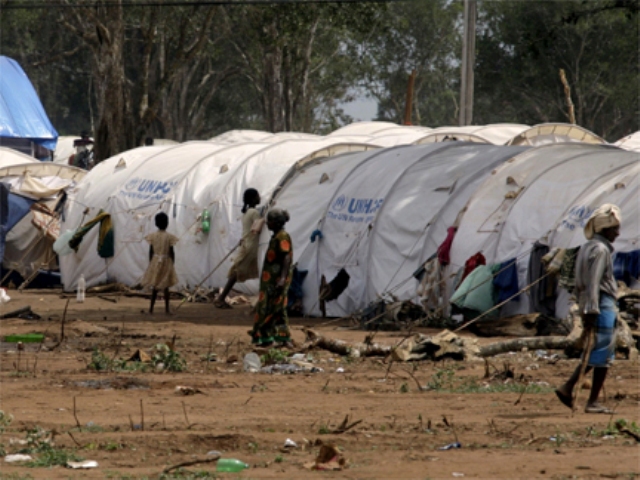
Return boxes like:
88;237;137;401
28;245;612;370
249;209;293;347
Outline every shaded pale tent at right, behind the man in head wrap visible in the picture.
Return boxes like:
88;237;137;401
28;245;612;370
450;143;638;315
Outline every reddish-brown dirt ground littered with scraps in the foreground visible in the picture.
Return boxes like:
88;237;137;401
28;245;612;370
0;290;640;479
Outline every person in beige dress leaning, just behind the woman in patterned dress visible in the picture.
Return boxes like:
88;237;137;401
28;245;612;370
213;188;261;308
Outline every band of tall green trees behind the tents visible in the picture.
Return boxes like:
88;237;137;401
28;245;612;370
0;0;640;159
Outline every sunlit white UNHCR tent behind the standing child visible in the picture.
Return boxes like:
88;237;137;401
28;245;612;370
61;138;372;290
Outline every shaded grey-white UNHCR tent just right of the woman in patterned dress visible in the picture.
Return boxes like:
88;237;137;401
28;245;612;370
274;142;522;315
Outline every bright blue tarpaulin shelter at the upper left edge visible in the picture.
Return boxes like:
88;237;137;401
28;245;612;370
0;56;58;150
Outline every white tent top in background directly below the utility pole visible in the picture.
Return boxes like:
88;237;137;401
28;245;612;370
415;123;529;145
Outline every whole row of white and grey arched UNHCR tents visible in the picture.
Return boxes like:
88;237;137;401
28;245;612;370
13;122;624;322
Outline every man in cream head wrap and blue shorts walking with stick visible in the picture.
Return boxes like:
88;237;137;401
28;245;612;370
556;204;622;413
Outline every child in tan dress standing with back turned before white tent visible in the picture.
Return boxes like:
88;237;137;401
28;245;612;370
142;212;178;314
